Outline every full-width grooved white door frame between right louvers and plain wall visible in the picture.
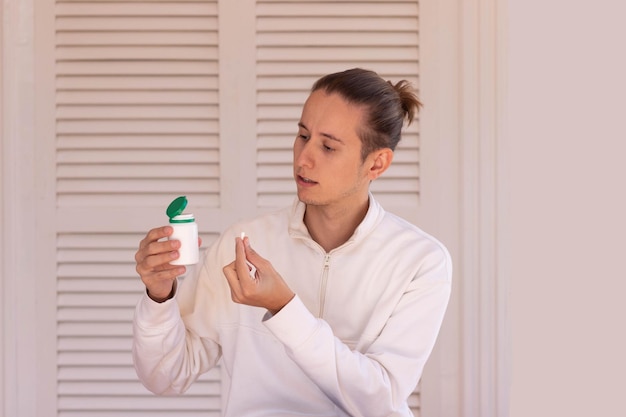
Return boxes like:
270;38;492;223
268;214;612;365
420;0;510;417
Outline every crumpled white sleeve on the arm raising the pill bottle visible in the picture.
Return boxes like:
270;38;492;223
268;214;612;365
132;256;221;395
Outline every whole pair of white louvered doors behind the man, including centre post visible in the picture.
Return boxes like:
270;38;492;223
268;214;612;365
42;0;420;417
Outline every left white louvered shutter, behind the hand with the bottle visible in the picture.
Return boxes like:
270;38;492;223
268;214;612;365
55;0;221;417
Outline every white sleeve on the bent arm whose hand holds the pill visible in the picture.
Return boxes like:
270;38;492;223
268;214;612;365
264;244;452;416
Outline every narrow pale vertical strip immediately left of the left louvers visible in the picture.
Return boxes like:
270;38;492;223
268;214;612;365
34;0;60;417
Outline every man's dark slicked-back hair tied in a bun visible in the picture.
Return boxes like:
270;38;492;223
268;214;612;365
311;68;422;160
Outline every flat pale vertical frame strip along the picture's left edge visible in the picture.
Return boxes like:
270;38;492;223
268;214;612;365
2;1;37;416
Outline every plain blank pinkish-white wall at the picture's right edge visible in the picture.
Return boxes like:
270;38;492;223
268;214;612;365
508;0;626;417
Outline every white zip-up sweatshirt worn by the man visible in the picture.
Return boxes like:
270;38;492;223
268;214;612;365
133;195;452;417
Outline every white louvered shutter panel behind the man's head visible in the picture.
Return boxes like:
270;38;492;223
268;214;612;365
257;0;419;213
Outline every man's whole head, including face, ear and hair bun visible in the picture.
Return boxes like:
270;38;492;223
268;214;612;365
294;69;419;211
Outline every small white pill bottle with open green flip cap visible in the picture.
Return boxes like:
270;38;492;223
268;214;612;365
166;196;200;265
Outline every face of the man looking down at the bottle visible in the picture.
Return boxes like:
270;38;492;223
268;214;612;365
293;90;370;208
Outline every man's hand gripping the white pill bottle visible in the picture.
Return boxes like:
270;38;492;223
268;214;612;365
135;226;186;302
